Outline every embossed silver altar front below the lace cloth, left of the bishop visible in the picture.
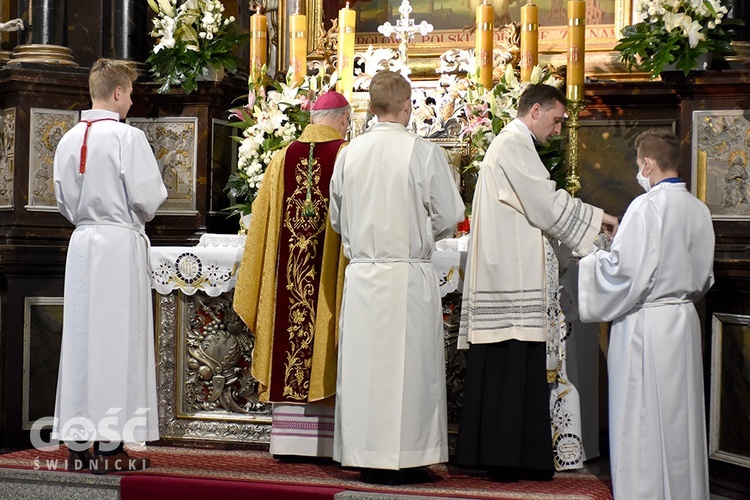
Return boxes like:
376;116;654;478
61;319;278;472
156;291;271;444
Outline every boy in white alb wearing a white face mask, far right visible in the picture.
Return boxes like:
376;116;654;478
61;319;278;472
578;129;714;500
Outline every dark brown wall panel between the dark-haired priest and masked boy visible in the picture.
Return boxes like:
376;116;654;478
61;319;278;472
578;120;676;217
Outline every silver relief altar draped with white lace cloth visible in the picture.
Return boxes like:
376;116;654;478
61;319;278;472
150;234;468;447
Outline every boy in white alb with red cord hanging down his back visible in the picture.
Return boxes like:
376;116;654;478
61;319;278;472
52;59;167;473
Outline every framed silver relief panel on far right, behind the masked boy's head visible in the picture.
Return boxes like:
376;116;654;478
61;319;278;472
692;109;750;220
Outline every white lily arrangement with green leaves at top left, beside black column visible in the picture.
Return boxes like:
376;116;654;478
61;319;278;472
146;0;248;94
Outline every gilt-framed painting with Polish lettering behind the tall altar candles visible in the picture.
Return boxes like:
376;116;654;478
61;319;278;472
308;0;632;57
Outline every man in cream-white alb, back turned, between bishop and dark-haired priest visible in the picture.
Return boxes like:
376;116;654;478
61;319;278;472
330;71;464;482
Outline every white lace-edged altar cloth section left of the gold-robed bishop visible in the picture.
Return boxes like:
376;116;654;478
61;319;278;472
151;234;245;297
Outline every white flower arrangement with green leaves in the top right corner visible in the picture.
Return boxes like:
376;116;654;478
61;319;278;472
615;0;741;79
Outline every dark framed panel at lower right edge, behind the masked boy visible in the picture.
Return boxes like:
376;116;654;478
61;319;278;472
708;314;750;467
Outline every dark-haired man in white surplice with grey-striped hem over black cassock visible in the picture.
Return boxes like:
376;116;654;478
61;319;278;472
456;84;617;481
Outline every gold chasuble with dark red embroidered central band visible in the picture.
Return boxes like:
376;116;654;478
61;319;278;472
234;124;347;404
